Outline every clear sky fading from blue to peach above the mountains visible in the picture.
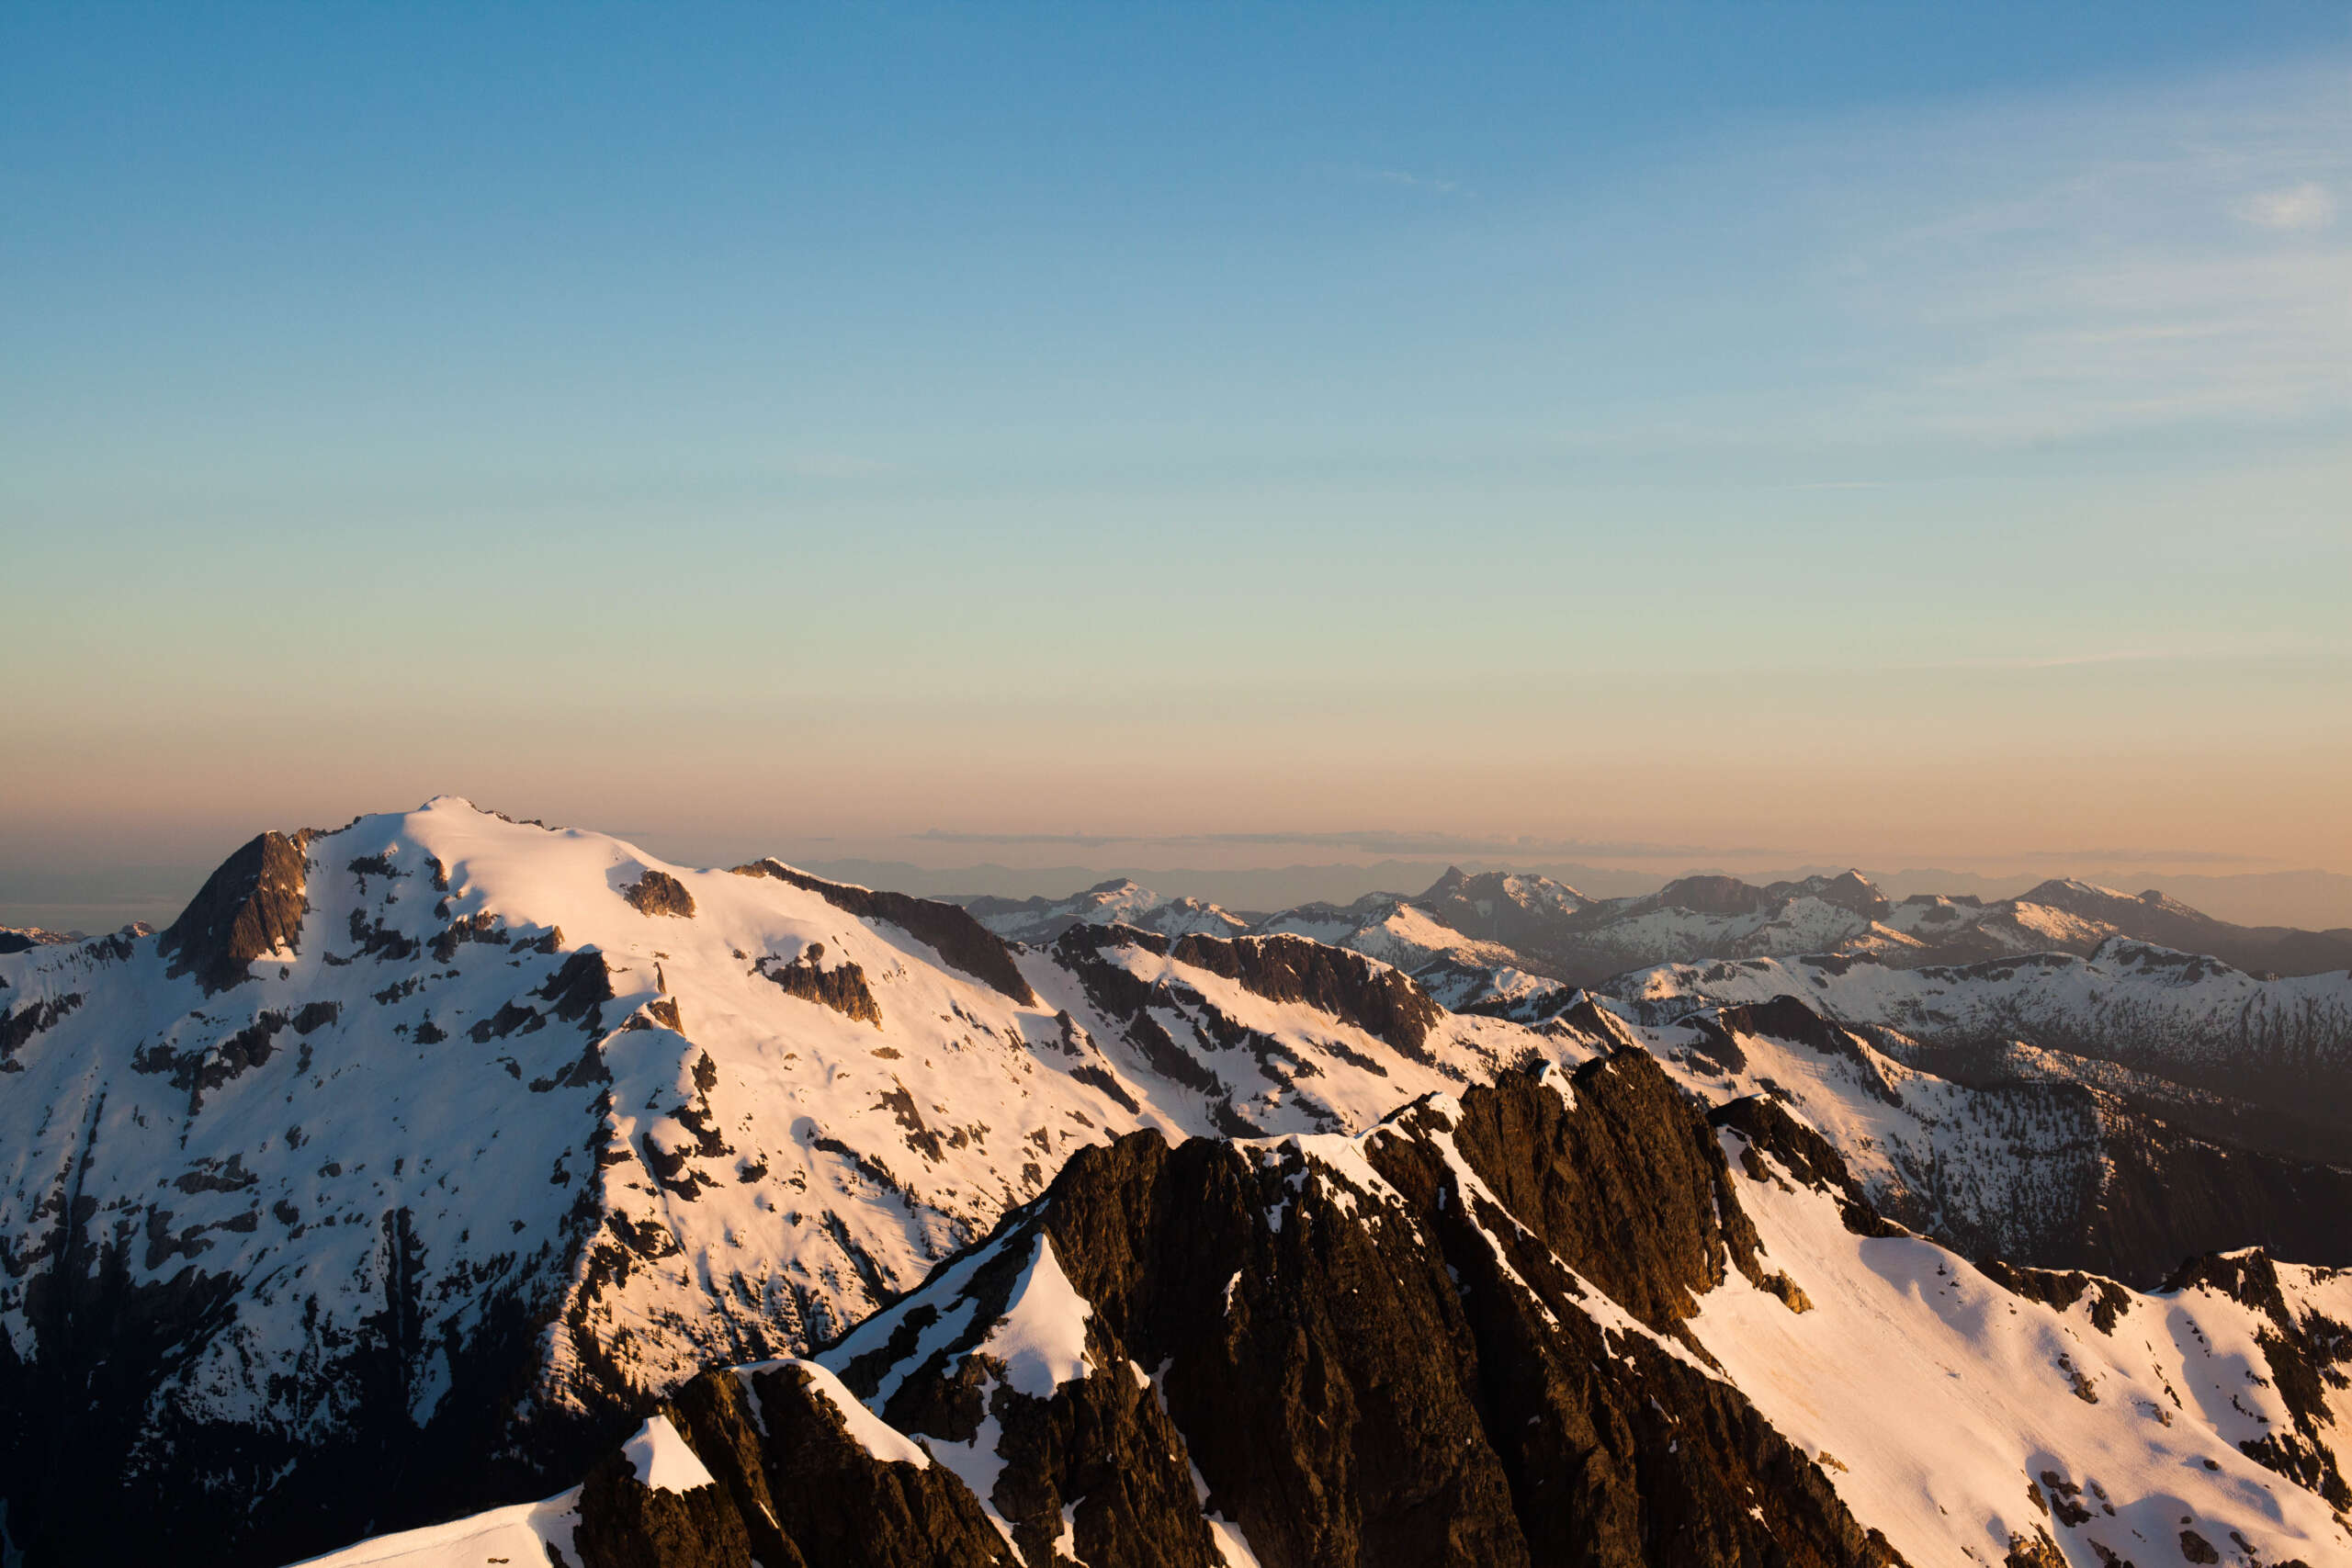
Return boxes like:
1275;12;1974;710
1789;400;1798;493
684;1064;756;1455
0;3;2352;929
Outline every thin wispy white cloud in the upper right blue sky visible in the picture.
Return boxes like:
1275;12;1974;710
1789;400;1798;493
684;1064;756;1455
1514;66;2352;463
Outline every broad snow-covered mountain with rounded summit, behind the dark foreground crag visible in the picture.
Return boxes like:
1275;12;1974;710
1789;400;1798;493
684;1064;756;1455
0;799;2352;1568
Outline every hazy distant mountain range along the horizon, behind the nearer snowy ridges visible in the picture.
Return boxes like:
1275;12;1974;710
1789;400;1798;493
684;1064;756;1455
965;870;2352;1161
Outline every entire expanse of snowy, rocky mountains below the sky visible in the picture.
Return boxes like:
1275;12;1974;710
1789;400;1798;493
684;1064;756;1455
0;797;2352;1568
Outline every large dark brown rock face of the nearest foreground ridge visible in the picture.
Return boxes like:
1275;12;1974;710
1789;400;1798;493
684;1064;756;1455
581;1051;1898;1568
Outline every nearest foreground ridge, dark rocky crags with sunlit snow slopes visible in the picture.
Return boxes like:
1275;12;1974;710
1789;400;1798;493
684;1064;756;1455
303;1048;2352;1568
